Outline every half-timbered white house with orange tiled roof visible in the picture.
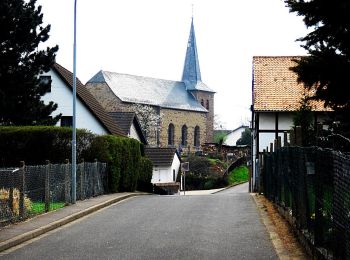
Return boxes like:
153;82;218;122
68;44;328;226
251;56;331;190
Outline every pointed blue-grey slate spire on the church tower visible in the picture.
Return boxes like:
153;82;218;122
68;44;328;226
182;17;201;89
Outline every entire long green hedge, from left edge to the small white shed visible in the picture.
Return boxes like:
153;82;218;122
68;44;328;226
0;126;152;192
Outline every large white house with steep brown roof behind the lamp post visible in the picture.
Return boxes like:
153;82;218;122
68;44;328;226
40;63;125;136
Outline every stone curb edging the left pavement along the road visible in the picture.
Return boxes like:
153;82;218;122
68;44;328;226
0;192;149;252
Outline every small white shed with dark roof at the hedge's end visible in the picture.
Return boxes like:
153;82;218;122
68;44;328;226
145;147;181;193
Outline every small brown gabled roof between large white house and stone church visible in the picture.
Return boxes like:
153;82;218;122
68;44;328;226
108;111;147;144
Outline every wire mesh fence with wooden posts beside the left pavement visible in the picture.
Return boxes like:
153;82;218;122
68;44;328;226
0;161;107;226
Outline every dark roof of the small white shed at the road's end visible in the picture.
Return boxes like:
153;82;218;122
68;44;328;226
145;147;181;167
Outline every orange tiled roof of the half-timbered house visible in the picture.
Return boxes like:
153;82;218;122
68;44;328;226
253;56;330;111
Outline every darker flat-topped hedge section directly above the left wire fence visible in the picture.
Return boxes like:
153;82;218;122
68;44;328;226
0;126;94;167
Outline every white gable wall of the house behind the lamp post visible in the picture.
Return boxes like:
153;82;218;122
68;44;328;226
42;70;108;134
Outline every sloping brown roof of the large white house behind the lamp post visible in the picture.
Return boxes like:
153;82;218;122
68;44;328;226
52;63;125;136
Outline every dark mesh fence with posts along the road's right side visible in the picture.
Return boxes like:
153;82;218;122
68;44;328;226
261;147;350;259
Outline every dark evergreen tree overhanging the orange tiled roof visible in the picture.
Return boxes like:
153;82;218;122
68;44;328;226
285;0;350;135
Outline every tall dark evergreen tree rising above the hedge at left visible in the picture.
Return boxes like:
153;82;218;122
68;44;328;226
0;0;59;125
